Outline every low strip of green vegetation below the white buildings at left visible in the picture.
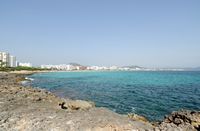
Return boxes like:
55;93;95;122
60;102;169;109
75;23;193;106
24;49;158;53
0;66;48;72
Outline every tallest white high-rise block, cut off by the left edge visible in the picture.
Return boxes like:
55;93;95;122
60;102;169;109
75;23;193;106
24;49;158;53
0;52;10;67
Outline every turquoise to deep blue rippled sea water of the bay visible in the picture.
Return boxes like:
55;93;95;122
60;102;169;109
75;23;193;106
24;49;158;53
30;71;200;120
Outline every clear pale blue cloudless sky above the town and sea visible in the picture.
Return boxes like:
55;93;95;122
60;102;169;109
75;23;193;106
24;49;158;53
0;0;200;67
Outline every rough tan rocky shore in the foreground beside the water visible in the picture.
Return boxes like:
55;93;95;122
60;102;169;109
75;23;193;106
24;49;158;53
0;73;200;131
